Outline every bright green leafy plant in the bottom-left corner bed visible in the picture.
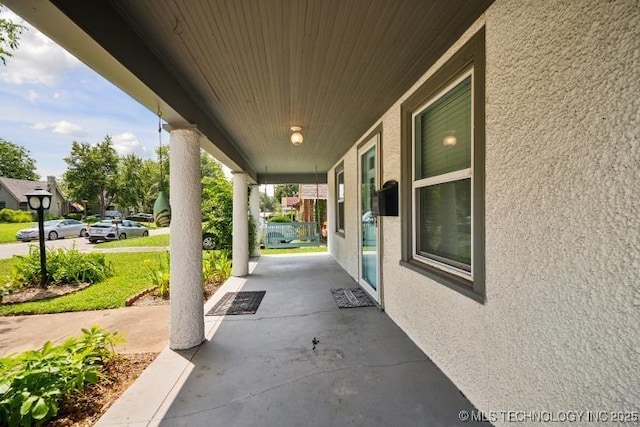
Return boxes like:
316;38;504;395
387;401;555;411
0;326;123;426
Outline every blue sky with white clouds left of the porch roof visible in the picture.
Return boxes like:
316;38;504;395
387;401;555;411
0;9;162;179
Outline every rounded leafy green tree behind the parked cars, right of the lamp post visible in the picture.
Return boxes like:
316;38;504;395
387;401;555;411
63;135;120;216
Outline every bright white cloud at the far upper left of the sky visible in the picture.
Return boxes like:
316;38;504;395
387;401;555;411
0;11;80;86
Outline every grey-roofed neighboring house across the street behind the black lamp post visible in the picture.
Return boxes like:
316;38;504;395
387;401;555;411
0;176;69;216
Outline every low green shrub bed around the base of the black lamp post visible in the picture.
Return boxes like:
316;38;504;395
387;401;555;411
13;246;114;286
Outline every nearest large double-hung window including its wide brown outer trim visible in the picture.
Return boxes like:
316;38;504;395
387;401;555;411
402;30;484;301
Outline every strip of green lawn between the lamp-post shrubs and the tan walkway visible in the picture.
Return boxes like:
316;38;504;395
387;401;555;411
0;252;165;315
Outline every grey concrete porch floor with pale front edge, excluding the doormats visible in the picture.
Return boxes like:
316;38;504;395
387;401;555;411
98;254;484;427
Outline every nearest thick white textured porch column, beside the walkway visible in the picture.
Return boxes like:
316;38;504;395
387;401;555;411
169;127;204;350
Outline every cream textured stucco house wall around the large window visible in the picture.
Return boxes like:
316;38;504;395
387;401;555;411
331;0;640;425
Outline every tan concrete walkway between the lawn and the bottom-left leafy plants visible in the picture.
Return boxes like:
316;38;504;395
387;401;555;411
0;305;169;356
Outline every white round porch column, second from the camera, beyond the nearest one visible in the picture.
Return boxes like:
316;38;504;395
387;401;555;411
231;172;249;277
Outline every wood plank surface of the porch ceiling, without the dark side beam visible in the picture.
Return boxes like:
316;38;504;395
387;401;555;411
54;0;492;179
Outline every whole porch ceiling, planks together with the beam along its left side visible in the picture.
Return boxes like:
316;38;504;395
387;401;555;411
4;0;493;183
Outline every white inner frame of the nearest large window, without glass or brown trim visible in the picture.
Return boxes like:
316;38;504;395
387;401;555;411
411;67;475;281
